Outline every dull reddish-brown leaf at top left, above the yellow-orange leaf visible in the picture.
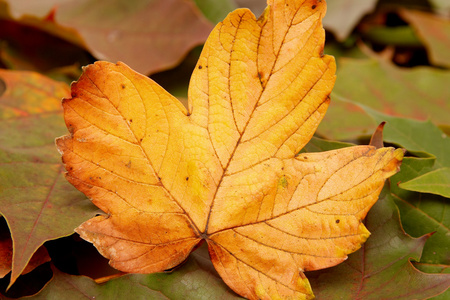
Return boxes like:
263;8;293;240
5;0;212;74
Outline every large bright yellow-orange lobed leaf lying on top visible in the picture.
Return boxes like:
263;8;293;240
57;0;403;299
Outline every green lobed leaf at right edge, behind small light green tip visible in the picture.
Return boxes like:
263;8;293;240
361;110;450;265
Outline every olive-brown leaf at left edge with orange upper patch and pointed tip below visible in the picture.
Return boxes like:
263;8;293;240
0;70;95;284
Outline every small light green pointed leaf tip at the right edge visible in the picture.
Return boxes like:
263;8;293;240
399;168;450;198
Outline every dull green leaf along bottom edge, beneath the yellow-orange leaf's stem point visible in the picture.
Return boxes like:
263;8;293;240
33;249;242;300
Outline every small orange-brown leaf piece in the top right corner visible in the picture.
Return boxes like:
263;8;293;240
399;9;450;68
